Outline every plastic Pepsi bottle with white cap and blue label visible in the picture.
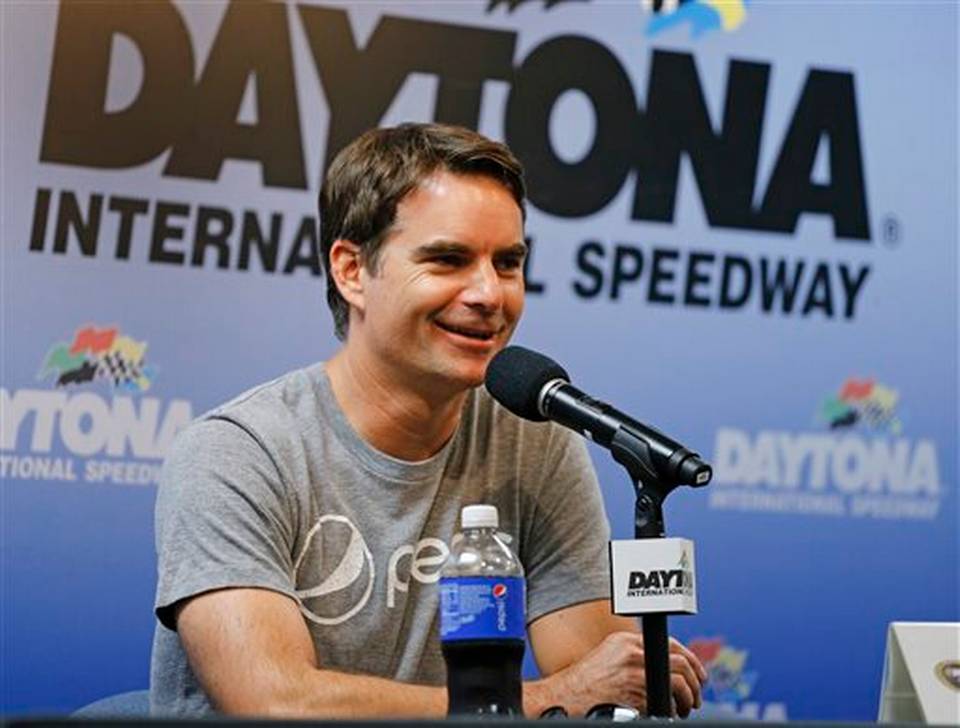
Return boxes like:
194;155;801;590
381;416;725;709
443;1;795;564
440;505;526;716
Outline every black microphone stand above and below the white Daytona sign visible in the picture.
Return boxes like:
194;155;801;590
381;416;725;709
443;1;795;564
610;428;677;718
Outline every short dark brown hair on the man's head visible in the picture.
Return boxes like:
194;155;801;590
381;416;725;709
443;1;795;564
319;124;525;339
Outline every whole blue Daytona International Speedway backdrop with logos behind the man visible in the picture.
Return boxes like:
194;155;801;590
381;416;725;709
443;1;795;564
0;0;960;721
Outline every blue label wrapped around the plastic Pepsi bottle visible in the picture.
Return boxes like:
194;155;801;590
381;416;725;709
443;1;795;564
440;576;527;642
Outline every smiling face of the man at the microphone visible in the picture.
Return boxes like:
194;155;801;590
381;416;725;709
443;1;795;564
349;171;526;393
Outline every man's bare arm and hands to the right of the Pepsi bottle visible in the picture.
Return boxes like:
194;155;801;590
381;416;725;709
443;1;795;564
524;599;707;717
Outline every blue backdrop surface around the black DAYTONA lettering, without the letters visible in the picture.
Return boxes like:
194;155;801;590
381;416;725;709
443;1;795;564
0;2;960;720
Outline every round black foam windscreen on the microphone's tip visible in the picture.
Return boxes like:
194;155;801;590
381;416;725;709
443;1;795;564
485;346;570;422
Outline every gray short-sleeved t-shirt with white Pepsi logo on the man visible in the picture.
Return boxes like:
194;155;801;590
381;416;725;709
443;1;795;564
151;364;609;715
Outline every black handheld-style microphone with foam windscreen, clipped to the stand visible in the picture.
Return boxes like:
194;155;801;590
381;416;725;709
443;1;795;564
485;346;713;487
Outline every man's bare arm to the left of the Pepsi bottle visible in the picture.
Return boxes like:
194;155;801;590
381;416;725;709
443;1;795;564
177;589;447;718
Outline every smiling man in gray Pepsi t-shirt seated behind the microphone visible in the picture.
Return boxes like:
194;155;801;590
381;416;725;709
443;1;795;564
151;124;705;717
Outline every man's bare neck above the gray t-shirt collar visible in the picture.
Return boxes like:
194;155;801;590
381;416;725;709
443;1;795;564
326;345;467;462
